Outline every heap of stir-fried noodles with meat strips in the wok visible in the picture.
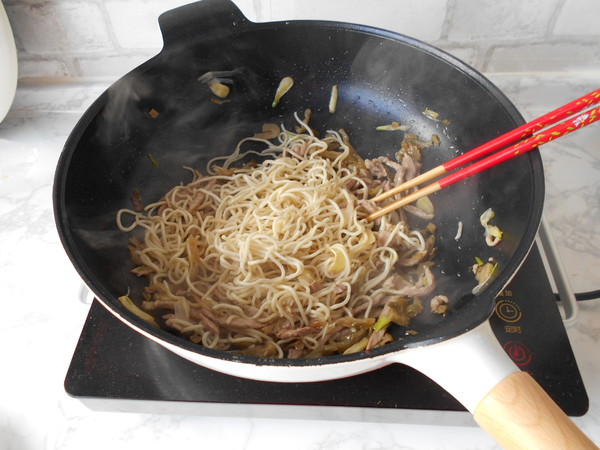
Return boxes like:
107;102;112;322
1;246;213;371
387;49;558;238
117;117;447;358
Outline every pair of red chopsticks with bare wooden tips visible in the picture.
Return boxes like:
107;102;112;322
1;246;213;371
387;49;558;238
366;89;600;221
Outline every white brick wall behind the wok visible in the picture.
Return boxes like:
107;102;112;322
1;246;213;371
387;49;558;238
3;0;600;78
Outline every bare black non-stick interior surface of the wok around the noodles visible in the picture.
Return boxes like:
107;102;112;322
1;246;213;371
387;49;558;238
55;4;543;364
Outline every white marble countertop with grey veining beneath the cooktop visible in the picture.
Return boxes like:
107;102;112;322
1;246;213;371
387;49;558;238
0;73;600;450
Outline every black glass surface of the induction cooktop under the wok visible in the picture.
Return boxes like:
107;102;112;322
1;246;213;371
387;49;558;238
65;247;588;416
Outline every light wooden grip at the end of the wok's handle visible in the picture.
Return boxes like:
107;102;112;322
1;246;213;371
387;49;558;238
473;372;598;450
